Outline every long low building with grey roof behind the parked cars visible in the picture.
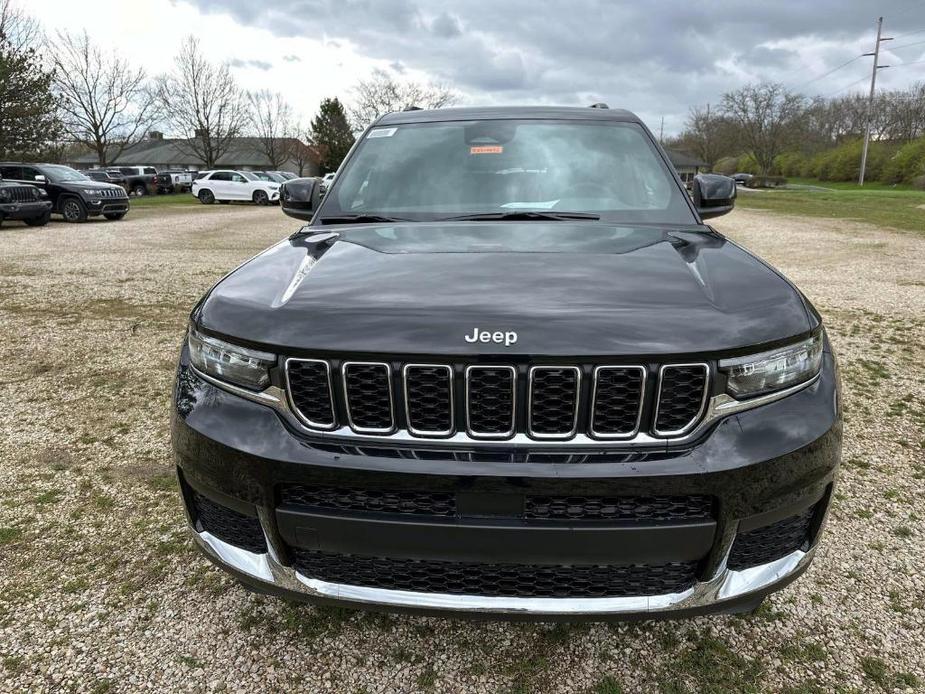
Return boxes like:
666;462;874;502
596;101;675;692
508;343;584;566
68;131;320;176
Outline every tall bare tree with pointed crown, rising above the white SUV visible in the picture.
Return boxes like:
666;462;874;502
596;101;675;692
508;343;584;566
157;36;250;168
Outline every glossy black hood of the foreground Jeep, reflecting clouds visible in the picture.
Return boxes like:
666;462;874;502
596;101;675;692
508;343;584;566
199;222;814;356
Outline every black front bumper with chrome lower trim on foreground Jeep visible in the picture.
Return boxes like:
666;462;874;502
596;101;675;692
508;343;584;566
172;353;841;619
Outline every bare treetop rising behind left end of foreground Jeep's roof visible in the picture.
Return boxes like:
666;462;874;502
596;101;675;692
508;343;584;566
350;70;459;130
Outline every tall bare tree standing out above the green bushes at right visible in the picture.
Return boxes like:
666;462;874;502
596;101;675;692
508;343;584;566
722;83;806;174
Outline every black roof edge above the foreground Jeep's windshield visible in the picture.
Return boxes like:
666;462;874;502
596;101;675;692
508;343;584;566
375;106;642;125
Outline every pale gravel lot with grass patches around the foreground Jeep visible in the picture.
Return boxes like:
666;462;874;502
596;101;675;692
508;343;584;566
0;206;925;693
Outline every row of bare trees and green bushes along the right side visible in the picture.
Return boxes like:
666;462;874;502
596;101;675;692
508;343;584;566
669;82;925;188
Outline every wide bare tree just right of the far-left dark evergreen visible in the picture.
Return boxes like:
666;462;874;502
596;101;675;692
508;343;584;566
48;31;157;166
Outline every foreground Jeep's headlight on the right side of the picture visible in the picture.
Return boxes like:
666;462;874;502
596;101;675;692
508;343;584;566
719;330;822;398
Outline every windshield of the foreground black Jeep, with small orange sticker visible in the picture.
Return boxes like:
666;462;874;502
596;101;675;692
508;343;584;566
320;120;695;224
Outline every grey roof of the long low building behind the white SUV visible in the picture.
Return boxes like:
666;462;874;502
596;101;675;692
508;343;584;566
73;137;314;168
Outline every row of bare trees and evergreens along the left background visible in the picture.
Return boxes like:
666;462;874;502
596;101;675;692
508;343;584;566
0;0;456;174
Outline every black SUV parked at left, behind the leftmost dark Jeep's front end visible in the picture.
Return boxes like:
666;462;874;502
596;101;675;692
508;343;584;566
0;162;128;222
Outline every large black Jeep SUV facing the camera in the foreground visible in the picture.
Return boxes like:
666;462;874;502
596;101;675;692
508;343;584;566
172;107;842;619
